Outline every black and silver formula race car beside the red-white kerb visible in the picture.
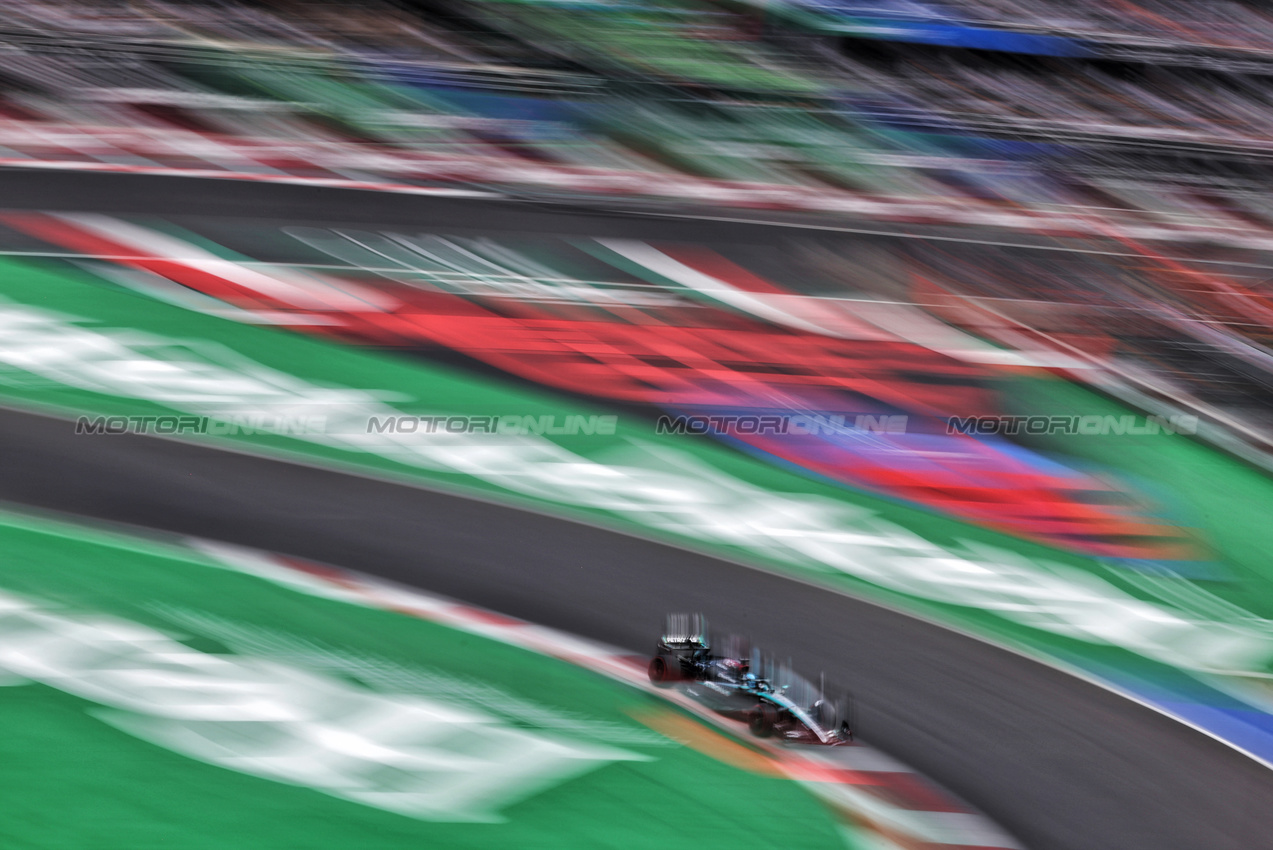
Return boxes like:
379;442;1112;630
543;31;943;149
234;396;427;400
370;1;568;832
648;615;853;746
